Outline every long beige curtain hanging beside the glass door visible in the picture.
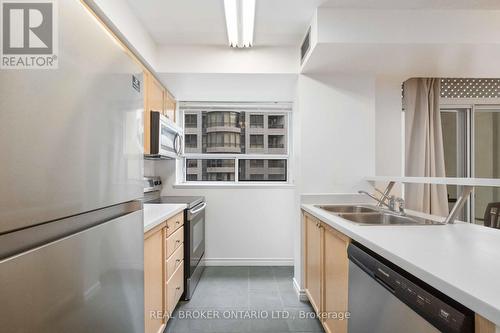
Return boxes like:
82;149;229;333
403;78;448;216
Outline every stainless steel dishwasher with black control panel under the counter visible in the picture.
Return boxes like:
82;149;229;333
348;242;474;333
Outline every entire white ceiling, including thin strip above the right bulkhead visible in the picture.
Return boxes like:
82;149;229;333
126;0;500;46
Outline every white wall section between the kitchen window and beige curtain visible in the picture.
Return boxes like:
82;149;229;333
294;74;375;285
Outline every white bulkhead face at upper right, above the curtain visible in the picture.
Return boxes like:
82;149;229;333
317;8;500;44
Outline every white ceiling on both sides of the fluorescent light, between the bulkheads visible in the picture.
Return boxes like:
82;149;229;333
127;0;324;46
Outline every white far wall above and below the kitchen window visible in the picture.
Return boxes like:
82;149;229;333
145;74;297;265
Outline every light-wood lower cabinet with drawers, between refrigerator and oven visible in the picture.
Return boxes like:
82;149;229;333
144;214;184;333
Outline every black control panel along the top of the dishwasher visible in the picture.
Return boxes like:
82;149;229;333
348;242;474;333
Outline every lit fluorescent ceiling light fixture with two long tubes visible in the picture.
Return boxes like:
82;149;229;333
224;0;255;47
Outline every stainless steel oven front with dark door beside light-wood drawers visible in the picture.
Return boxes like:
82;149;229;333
184;201;207;300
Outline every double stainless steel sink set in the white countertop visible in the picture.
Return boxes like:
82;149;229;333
315;205;443;225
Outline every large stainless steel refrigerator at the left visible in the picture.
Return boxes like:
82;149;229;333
0;0;144;333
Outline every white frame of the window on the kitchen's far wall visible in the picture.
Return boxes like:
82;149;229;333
174;102;294;188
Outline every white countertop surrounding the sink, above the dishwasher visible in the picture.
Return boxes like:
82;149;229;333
301;204;500;325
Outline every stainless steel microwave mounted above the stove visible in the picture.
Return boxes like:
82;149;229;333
146;111;183;159
